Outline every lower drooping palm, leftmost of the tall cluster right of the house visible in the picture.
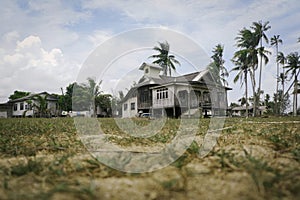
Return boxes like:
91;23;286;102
231;49;250;117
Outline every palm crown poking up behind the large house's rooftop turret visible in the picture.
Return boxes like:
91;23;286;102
149;41;180;76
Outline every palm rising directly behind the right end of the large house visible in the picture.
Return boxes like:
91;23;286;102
208;44;229;86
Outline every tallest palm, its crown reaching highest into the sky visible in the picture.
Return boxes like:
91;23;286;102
251;21;271;107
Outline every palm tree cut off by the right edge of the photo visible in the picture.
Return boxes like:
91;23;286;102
285;52;300;116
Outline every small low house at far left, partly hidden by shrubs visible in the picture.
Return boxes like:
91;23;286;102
7;92;59;117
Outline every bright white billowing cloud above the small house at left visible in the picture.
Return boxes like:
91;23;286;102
0;35;79;102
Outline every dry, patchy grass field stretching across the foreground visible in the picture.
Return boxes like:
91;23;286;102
0;117;300;199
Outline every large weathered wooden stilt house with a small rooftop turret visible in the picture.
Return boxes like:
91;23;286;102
122;63;231;118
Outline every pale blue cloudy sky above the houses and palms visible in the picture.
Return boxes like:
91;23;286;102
0;0;300;106
